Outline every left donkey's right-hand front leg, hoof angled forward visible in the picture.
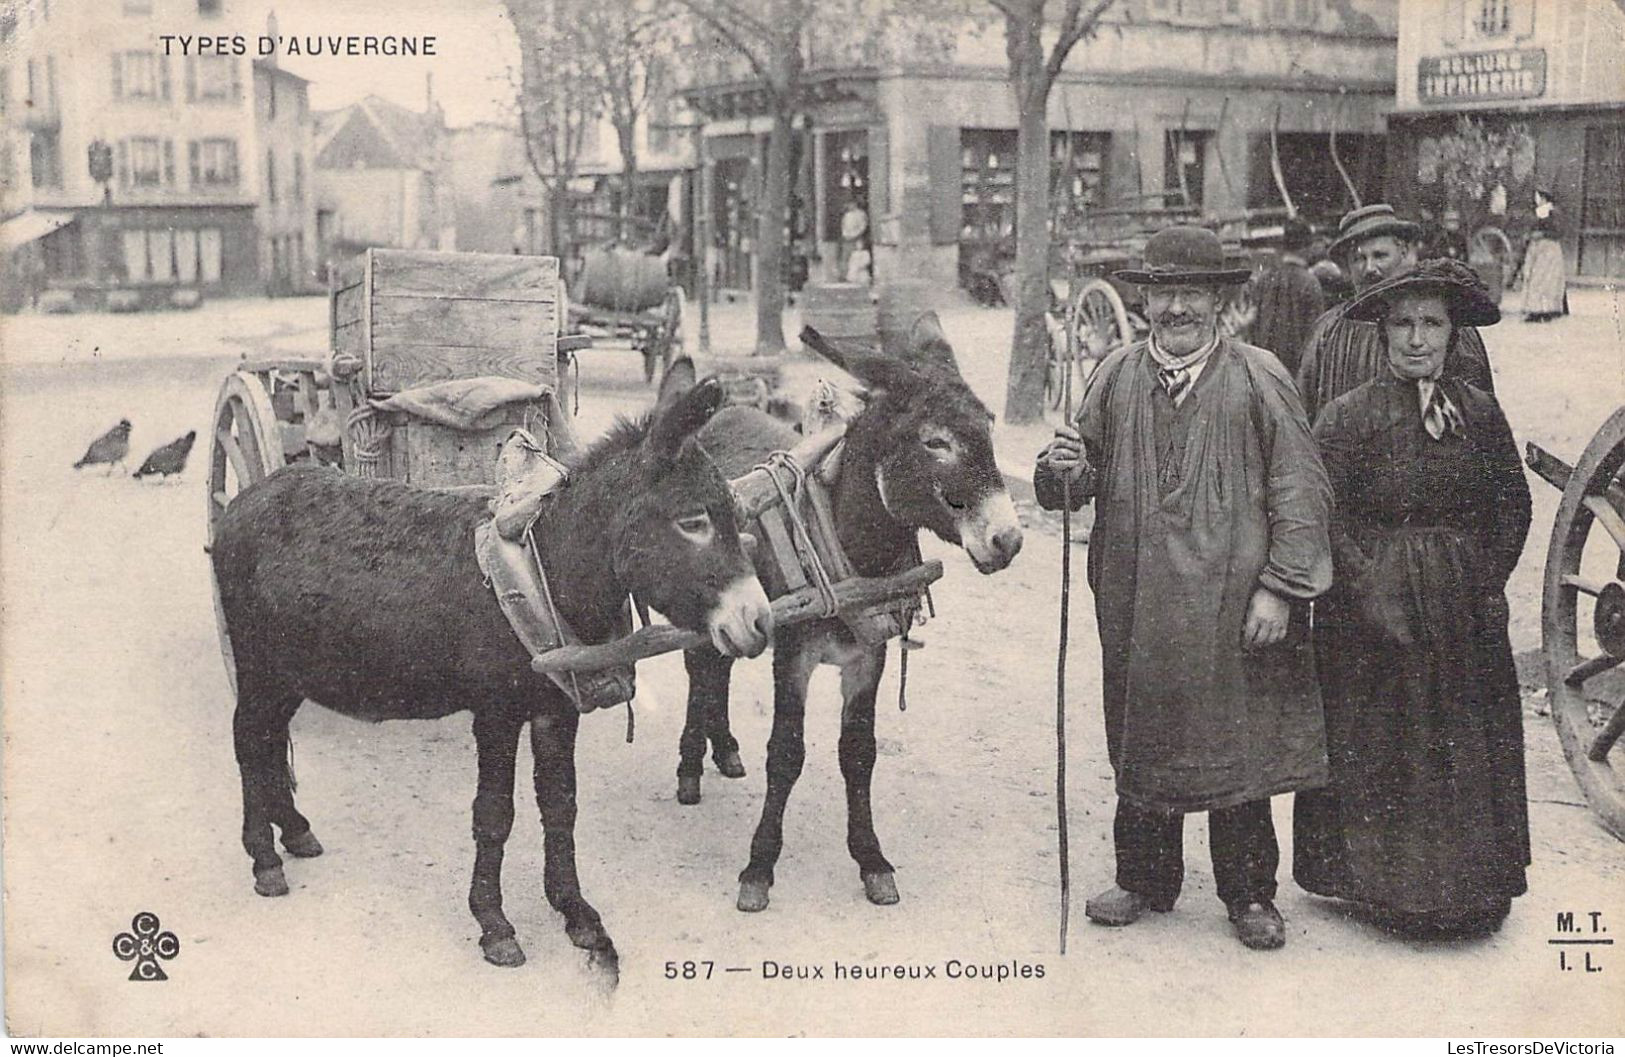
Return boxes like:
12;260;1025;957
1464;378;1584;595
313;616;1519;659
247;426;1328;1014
530;704;621;976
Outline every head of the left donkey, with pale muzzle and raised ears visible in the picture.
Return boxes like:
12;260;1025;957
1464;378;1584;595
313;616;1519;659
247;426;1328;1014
613;374;774;657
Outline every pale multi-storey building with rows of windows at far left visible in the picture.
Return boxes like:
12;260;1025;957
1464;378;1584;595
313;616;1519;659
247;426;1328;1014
0;0;314;306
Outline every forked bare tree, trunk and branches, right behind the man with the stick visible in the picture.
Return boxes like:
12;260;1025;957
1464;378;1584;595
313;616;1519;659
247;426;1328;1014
988;0;1113;424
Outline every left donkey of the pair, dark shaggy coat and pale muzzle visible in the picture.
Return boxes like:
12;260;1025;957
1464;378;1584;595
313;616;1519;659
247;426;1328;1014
213;385;772;969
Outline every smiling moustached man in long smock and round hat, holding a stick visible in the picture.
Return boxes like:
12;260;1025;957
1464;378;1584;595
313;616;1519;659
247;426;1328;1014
1034;226;1331;950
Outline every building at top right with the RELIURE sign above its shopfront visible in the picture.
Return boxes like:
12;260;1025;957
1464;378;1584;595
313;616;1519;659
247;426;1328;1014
1389;0;1625;278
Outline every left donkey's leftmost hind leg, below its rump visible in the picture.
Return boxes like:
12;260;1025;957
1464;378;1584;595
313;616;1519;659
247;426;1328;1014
231;665;299;896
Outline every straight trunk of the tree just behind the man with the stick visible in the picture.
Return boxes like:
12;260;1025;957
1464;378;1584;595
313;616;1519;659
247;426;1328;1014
1004;20;1050;426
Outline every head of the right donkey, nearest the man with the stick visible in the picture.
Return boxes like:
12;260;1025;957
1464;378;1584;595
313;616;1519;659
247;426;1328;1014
801;312;1022;572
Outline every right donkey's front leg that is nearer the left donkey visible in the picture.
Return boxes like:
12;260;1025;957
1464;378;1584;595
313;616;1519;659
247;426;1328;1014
738;636;817;912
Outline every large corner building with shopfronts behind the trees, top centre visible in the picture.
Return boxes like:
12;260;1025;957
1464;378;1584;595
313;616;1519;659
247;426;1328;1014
687;0;1398;286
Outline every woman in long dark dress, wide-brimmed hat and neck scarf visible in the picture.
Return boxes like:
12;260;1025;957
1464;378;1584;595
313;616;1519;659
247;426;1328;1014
1294;260;1529;935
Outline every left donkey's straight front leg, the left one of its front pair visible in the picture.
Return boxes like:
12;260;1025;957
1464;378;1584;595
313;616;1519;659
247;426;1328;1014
468;709;525;968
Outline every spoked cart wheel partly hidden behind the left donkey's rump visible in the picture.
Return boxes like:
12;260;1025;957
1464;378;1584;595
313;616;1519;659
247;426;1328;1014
205;371;283;691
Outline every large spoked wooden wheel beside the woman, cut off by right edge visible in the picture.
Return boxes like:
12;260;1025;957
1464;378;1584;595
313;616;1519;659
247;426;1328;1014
1541;408;1625;841
